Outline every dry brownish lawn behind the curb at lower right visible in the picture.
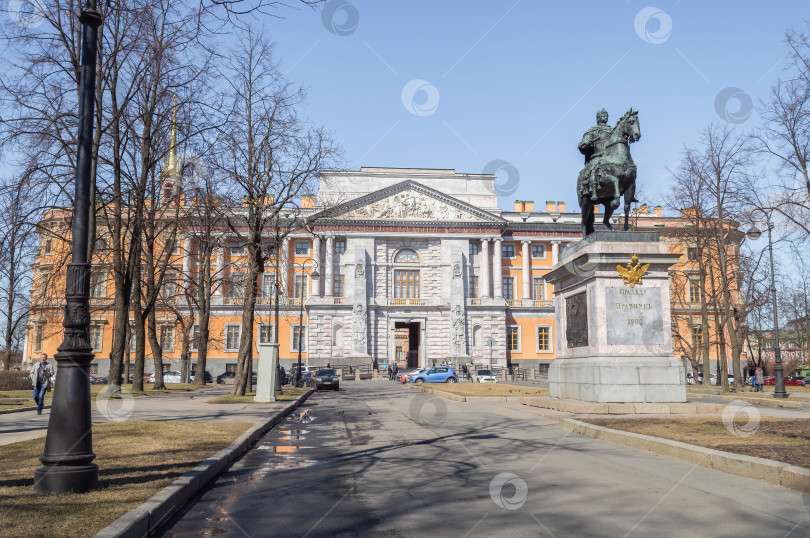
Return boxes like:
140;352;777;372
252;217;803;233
579;413;810;468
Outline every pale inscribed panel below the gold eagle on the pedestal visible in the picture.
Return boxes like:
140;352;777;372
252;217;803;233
605;286;664;346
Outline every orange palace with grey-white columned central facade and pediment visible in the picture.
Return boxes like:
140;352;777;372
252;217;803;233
24;168;728;376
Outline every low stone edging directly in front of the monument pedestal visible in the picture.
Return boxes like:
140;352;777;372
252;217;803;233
520;396;728;415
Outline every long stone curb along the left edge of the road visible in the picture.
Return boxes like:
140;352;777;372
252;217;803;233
95;389;315;538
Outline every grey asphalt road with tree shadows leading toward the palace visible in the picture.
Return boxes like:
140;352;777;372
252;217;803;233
162;382;810;538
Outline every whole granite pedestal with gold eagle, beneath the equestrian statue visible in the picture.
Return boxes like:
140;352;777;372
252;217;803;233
545;231;686;402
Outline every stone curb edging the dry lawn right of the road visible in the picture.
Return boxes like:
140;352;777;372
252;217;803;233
560;418;810;493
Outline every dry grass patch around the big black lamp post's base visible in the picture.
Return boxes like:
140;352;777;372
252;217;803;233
0;421;251;537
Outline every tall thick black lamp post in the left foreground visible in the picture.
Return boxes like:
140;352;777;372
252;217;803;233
34;0;101;495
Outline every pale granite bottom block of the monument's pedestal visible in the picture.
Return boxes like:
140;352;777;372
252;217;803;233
548;356;686;403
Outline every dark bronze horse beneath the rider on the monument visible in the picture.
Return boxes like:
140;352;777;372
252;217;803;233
577;108;641;237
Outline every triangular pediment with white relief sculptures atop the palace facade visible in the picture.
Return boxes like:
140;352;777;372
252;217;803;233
318;181;504;223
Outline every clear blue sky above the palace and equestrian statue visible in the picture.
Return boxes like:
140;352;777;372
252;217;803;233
260;0;810;211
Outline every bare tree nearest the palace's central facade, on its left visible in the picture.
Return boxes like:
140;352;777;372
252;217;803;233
218;29;335;394
